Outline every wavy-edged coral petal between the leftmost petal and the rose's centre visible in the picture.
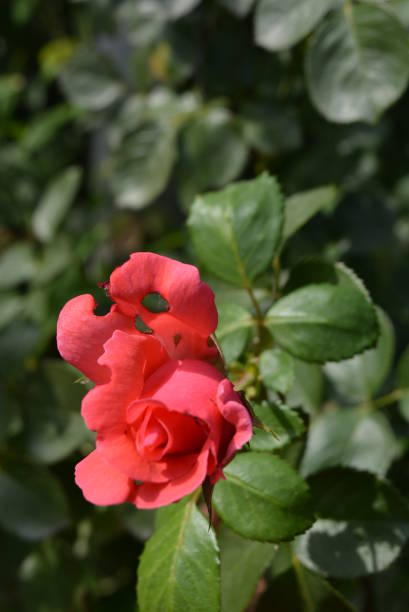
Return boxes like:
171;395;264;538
81;331;168;433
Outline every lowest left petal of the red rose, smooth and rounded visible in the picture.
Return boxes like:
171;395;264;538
75;450;135;506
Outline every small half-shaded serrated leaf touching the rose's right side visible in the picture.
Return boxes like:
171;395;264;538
250;402;305;451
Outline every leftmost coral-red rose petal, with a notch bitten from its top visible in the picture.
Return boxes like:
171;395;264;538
57;294;136;383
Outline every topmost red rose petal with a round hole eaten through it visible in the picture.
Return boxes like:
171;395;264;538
109;253;217;356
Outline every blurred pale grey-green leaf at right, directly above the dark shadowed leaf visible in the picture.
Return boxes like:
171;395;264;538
301;409;398;476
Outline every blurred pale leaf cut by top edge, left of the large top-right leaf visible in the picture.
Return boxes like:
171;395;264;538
254;0;334;51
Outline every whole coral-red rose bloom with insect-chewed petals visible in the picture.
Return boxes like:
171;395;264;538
57;253;252;508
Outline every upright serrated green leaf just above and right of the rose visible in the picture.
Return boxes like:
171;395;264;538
188;174;283;287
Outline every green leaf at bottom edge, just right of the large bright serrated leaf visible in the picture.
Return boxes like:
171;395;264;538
218;525;275;612
